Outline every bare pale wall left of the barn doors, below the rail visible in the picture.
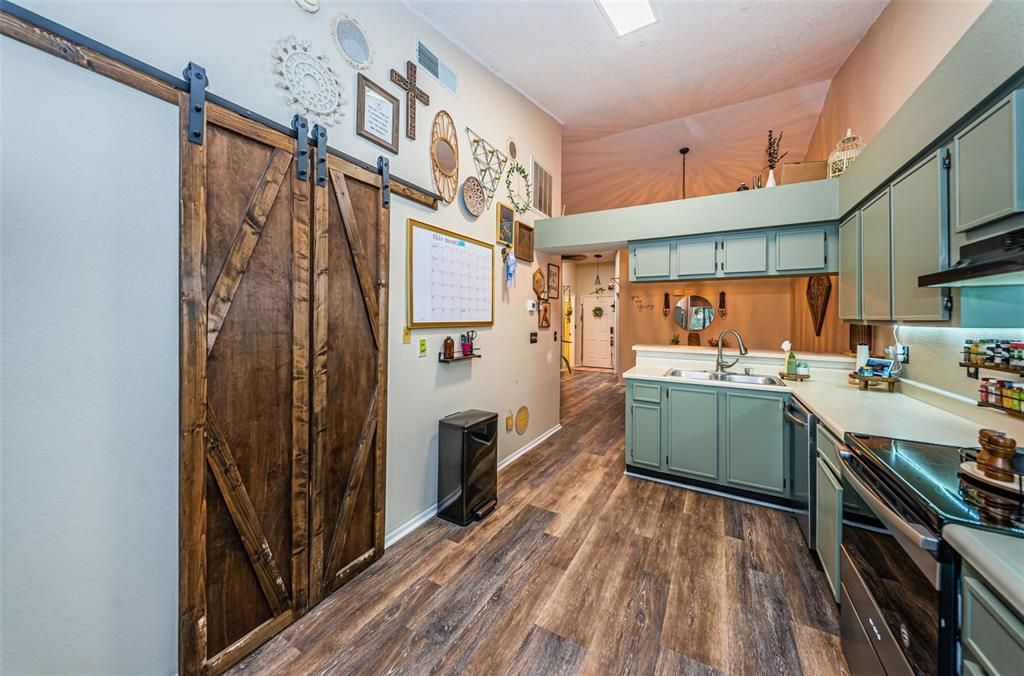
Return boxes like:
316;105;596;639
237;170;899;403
0;39;178;674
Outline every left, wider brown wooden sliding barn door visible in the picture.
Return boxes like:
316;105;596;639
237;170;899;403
179;96;311;674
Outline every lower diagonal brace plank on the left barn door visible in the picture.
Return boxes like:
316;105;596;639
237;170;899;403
206;408;292;615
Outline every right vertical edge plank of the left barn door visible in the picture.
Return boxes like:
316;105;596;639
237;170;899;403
292;172;310;611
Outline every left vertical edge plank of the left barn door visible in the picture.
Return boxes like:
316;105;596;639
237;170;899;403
178;94;207;675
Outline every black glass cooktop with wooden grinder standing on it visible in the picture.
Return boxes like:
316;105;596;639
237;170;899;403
847;434;1024;538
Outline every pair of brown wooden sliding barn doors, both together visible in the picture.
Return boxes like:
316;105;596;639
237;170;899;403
179;94;388;674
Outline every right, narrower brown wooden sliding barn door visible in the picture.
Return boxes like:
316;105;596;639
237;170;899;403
310;157;389;602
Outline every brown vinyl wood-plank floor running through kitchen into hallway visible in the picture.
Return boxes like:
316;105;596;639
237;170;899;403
233;371;849;675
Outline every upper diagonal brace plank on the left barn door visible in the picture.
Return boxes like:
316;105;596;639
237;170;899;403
207;150;292;353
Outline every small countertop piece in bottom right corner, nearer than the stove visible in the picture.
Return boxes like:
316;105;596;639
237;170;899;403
942;525;1024;616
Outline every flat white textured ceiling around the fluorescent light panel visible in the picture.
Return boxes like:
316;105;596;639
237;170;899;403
406;0;888;144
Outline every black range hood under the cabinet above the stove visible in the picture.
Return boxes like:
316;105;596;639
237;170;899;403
918;227;1024;287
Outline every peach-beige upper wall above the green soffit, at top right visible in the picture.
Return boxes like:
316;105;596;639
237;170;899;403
805;0;989;160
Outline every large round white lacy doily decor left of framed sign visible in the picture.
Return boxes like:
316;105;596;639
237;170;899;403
272;35;347;127
